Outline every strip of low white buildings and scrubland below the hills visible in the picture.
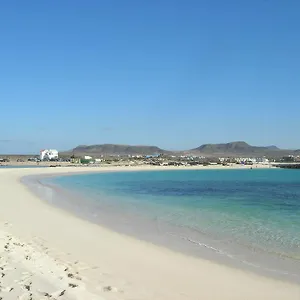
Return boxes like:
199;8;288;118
0;149;300;168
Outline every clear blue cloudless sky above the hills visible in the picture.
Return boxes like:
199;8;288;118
0;0;300;153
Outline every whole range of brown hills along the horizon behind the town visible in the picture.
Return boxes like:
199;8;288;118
65;141;300;157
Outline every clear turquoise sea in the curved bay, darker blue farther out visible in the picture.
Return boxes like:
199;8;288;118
41;169;300;280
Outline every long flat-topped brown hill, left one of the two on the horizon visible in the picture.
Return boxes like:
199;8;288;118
67;144;168;156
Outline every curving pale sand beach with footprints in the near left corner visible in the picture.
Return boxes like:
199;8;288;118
0;167;300;300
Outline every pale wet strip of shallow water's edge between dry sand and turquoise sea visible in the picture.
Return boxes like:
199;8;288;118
25;169;300;284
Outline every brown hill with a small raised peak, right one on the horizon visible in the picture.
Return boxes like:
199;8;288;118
191;141;294;156
